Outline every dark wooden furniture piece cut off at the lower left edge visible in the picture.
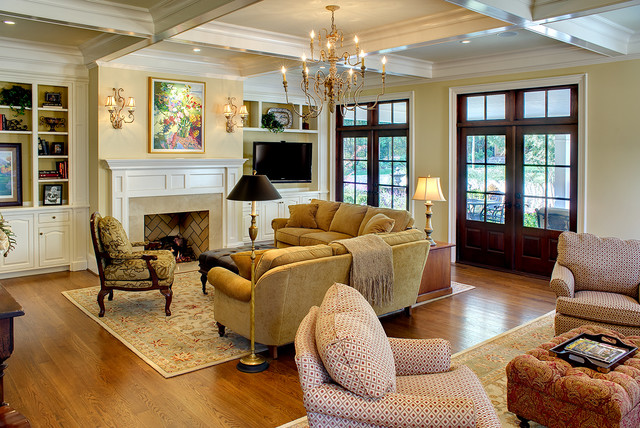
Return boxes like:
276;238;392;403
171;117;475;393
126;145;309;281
0;285;31;428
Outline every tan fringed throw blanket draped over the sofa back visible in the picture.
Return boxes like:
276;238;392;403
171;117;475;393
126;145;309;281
337;234;393;306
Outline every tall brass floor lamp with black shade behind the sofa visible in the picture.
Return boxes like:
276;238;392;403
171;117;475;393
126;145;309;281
227;171;282;373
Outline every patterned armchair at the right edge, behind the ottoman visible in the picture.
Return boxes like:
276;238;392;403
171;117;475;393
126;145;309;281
550;232;640;336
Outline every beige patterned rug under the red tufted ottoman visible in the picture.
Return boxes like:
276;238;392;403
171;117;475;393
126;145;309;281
279;311;554;428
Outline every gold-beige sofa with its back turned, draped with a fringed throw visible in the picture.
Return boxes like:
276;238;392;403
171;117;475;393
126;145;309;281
208;229;430;357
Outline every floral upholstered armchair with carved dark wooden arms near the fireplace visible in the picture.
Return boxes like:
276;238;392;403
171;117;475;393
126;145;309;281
91;212;176;317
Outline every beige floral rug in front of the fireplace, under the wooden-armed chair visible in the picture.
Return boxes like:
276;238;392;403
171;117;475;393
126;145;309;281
62;271;266;378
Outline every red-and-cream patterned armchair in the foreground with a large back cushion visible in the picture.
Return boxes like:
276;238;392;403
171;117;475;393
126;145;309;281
295;283;501;427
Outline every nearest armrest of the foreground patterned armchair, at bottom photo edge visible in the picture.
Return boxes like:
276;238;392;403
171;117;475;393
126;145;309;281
304;383;476;428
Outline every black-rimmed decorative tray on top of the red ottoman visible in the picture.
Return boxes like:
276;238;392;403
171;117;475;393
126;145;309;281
549;333;638;373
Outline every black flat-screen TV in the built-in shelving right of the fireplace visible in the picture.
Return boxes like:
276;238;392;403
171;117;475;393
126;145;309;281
253;141;312;183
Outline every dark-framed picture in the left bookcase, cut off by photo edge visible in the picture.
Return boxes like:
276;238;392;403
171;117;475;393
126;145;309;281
0;143;22;207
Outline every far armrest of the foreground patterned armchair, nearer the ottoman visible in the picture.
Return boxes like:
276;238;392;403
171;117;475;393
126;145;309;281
389;337;451;376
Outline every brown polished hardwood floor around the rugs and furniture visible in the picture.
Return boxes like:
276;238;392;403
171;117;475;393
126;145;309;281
1;265;555;427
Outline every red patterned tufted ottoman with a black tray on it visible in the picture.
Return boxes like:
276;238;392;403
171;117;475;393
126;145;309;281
507;325;640;428
